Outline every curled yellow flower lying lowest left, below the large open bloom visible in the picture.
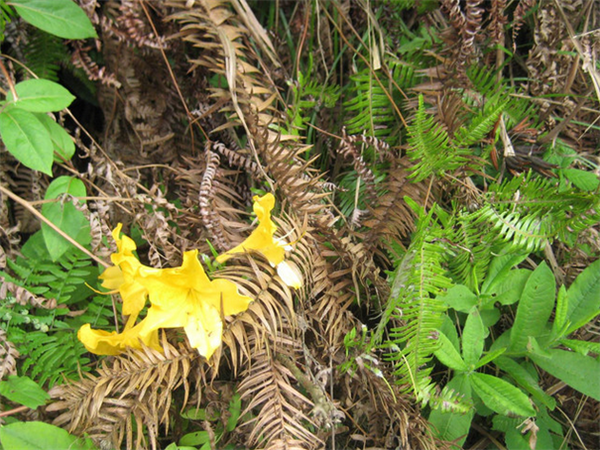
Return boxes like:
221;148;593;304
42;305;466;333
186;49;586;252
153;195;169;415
77;318;162;355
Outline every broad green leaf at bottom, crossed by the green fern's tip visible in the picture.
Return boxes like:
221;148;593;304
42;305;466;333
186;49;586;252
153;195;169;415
429;374;475;448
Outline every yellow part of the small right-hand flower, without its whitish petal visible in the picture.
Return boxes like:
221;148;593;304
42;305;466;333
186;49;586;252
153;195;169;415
217;193;285;267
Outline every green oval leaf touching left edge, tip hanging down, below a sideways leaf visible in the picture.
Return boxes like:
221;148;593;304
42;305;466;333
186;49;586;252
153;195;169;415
0;108;54;175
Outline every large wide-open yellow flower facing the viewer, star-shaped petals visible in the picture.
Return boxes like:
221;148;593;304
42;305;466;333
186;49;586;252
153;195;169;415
137;250;252;359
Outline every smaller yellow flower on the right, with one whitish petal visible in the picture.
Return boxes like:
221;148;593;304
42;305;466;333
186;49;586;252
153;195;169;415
217;193;302;289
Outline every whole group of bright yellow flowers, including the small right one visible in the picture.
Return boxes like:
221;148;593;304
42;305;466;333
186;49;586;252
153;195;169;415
77;194;302;359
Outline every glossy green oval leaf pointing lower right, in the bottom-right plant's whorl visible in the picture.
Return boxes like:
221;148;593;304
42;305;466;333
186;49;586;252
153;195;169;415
470;372;535;417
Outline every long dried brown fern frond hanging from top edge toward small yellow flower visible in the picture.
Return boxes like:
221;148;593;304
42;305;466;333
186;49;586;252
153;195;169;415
169;0;324;220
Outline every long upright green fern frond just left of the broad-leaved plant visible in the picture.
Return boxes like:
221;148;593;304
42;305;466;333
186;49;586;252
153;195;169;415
376;199;452;397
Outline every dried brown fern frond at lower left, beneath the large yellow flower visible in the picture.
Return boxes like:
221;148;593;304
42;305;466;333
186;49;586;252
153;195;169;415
47;335;199;449
